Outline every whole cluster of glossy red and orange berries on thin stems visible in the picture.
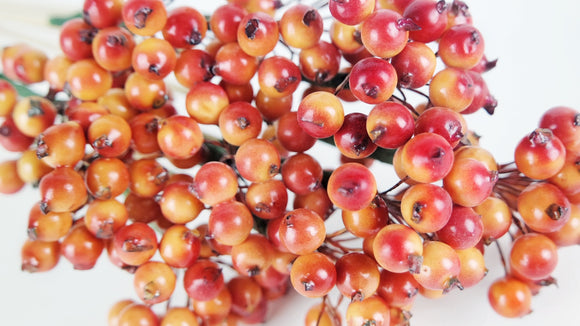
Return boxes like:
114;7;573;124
0;0;580;326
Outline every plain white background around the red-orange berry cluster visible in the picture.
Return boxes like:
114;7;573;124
0;0;580;326
